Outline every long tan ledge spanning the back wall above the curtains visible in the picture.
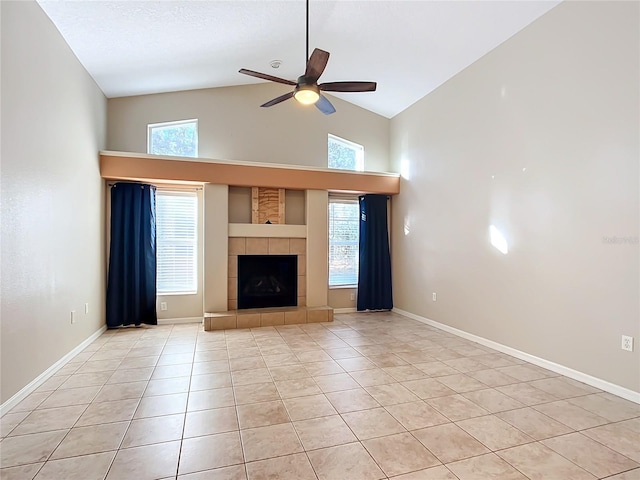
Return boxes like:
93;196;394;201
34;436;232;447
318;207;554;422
100;151;400;195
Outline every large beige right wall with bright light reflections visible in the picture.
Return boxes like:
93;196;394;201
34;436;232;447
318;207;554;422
391;2;640;391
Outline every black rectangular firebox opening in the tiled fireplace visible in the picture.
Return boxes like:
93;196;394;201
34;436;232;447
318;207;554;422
238;255;298;310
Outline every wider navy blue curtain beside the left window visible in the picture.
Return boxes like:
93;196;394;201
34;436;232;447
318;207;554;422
107;182;158;328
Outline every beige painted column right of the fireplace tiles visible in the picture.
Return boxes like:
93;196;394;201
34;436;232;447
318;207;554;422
306;190;329;307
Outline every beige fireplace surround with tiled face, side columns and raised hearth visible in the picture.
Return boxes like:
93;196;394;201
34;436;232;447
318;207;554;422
204;185;333;330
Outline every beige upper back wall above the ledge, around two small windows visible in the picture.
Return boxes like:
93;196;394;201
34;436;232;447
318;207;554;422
107;83;389;172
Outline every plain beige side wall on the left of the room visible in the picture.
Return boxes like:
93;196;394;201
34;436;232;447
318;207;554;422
0;1;106;402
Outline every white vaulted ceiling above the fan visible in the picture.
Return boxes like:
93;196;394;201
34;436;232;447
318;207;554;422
38;0;559;118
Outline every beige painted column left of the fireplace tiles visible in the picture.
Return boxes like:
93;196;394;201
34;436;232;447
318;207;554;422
204;184;229;312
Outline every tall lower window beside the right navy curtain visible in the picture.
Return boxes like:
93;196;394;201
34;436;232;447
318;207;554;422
329;198;360;287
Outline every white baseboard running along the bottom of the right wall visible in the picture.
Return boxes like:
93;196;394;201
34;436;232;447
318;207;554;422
393;308;640;403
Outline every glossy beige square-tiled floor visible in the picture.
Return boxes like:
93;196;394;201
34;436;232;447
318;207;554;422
0;313;640;480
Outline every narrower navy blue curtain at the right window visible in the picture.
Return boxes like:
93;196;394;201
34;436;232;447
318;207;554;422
358;195;393;311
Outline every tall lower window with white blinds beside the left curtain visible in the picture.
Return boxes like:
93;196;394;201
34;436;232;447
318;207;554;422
156;190;198;295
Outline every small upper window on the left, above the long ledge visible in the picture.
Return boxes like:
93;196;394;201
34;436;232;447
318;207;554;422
147;120;198;157
